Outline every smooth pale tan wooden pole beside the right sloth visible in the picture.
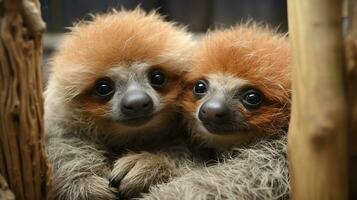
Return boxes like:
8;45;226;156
288;0;348;200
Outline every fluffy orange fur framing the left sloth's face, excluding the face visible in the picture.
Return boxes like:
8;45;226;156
51;9;191;134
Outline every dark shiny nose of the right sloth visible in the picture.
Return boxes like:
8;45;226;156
198;99;230;123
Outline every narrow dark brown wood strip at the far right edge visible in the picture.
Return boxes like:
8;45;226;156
345;1;357;199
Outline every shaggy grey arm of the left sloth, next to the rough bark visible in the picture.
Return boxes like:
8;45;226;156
46;136;117;200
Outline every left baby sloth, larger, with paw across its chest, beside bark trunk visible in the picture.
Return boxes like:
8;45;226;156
45;9;191;200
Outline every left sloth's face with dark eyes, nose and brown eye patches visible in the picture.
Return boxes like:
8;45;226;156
75;62;179;128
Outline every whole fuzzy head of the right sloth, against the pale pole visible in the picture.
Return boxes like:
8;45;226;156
182;25;291;148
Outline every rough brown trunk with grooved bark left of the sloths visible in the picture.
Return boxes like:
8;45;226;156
0;0;51;200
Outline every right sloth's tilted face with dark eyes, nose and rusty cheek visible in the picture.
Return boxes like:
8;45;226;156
184;73;288;147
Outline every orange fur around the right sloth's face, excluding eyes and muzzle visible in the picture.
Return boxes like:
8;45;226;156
182;25;291;148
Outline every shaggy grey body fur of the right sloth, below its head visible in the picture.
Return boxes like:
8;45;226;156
142;137;290;200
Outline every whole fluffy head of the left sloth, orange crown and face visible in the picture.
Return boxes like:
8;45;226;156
45;9;192;141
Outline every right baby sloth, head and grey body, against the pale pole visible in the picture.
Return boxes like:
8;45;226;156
145;24;291;200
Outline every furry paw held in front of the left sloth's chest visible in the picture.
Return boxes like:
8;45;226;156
110;142;195;197
